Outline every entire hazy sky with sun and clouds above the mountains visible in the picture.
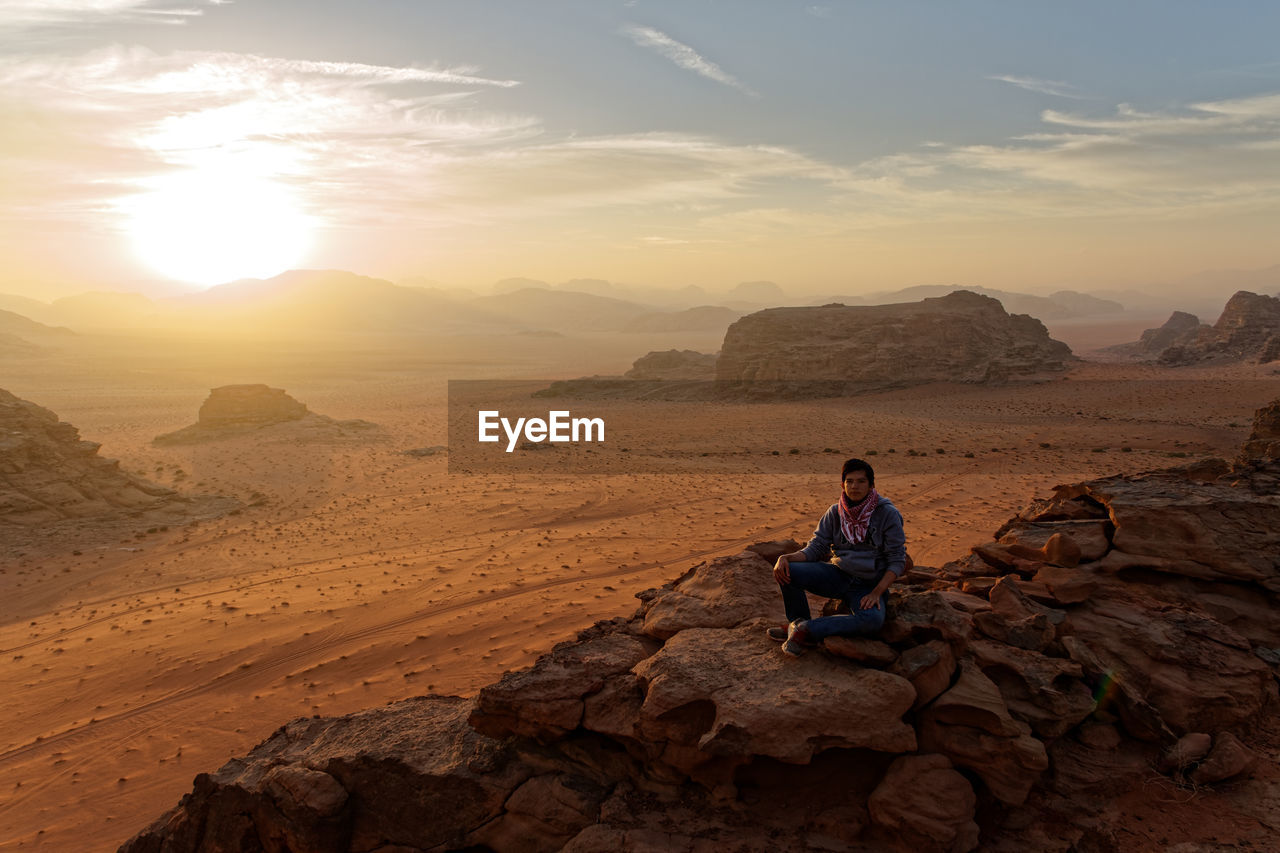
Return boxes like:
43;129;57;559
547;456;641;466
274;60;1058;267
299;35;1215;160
0;0;1280;296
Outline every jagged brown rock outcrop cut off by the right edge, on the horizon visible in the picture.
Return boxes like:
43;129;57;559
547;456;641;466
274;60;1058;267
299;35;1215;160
1143;291;1280;366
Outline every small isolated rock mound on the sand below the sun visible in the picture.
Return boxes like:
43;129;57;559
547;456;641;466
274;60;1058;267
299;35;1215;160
154;384;374;444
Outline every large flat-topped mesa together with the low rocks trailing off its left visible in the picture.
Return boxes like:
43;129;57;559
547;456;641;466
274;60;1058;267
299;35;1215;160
538;291;1076;400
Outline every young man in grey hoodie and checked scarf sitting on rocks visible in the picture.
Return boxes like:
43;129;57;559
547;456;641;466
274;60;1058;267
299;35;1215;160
769;459;906;657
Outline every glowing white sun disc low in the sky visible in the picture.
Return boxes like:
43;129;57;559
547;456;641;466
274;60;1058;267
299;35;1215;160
127;169;311;286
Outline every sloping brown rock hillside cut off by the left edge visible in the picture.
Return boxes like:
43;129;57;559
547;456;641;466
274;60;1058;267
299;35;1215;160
0;389;237;544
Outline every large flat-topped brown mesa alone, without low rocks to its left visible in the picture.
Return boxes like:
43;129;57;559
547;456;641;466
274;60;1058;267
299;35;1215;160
716;285;1073;396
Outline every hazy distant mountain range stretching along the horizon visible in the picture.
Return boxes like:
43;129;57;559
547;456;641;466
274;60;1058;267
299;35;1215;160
0;265;1280;337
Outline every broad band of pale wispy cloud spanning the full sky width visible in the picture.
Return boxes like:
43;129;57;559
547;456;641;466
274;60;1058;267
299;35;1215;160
0;36;1280;268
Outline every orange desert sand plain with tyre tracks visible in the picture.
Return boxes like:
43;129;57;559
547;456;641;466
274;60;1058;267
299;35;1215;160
0;329;1280;850
